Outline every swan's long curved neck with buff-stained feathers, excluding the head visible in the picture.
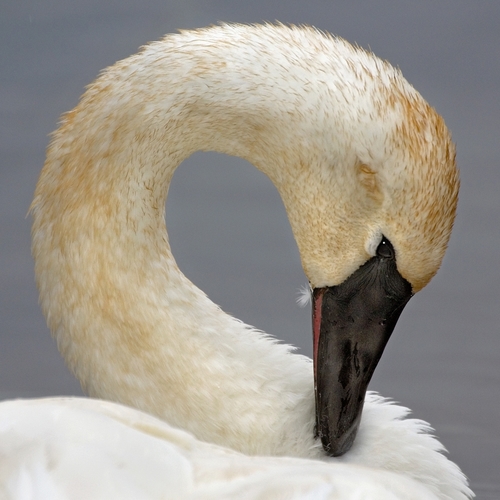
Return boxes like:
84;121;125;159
33;26;340;455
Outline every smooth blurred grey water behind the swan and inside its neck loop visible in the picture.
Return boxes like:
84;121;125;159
0;0;500;499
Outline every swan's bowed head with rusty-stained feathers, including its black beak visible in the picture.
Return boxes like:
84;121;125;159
266;53;459;456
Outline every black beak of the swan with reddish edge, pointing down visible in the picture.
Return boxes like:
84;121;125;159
313;238;412;457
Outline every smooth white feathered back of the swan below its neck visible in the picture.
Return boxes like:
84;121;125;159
0;398;463;500
